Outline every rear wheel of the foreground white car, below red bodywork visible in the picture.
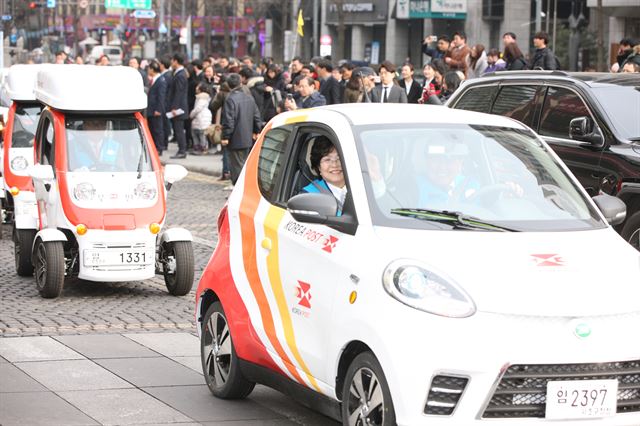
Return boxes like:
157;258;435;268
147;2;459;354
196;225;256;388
200;302;255;399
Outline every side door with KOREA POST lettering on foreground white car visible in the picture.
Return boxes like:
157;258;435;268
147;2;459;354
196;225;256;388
259;125;355;394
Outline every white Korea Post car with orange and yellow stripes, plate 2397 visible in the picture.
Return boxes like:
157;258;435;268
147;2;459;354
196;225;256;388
195;104;640;426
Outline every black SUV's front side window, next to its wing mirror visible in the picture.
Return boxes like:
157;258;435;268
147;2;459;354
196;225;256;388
538;87;590;139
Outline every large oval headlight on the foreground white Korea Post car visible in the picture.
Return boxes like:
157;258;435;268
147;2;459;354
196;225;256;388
382;259;476;318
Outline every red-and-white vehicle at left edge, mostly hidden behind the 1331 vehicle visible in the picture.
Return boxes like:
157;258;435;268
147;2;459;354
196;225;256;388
2;65;45;264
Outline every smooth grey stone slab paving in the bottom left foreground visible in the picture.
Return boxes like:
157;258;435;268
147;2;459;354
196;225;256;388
0;333;336;426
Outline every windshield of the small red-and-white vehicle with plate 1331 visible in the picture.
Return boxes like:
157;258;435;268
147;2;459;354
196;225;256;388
65;116;152;172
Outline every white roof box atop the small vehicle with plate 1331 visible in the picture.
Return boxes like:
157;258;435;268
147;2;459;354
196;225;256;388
35;64;147;113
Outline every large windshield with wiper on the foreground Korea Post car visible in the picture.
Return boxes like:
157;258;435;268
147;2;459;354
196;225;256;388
356;124;606;231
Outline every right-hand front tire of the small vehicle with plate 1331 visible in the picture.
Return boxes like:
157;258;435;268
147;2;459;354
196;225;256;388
161;241;194;296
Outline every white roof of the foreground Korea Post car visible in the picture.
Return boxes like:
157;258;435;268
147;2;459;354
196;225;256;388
296;103;525;129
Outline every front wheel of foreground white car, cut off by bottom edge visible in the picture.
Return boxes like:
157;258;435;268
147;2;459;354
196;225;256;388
342;352;396;426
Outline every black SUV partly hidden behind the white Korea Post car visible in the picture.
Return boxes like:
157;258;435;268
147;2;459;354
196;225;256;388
447;71;640;250
